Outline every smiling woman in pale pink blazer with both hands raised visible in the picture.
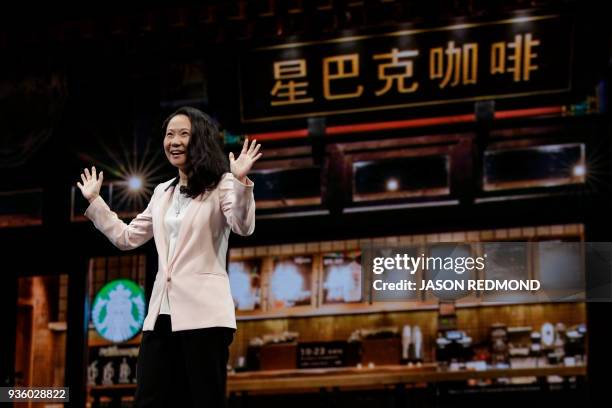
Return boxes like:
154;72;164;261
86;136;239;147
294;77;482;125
77;107;262;407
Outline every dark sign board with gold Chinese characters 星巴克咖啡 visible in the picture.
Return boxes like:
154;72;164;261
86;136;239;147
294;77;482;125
240;15;572;123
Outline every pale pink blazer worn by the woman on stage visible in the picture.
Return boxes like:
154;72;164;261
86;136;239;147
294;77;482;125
85;173;255;331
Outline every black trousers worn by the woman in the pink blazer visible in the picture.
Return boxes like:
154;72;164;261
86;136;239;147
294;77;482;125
135;315;235;408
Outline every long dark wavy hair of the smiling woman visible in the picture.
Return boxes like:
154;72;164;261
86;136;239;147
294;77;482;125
162;106;229;198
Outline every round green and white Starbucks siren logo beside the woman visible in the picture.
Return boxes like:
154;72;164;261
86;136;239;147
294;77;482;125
91;279;145;343
